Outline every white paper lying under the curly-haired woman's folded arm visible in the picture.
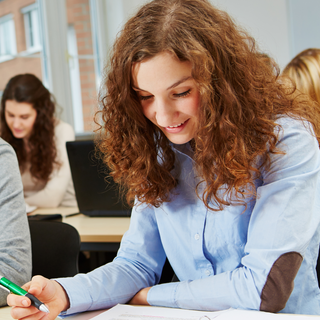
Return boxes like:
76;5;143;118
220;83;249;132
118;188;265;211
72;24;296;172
91;304;320;320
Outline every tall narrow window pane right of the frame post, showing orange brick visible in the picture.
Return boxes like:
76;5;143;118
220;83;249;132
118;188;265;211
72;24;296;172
65;0;101;135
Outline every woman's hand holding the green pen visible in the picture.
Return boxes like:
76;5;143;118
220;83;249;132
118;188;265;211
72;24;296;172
7;276;70;320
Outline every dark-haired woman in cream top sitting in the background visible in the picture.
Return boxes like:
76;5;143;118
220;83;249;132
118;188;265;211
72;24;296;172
0;74;77;207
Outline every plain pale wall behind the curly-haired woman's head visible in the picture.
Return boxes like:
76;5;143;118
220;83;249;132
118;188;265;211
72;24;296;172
105;0;320;72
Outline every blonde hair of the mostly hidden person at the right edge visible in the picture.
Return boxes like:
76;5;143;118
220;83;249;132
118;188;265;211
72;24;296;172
282;48;320;105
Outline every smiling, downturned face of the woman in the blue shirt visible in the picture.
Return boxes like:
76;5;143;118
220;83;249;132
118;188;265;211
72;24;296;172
132;52;200;144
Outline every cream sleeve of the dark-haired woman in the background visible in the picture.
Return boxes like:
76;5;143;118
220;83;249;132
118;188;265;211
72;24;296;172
25;122;75;208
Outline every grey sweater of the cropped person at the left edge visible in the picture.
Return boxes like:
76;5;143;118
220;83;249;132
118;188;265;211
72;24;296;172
0;138;32;306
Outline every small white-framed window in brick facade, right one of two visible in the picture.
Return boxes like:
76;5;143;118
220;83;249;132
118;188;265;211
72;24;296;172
21;3;41;52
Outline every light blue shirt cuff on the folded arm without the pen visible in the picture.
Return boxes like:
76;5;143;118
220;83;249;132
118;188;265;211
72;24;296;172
147;282;180;308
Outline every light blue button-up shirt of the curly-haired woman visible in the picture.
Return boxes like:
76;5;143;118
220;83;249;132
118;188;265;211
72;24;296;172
59;118;320;314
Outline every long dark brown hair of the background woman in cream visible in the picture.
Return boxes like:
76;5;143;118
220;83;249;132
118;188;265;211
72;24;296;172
0;74;59;183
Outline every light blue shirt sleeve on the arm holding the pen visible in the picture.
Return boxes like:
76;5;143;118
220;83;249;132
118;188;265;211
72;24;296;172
56;205;166;314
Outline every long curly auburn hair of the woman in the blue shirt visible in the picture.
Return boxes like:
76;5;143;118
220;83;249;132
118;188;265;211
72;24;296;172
96;0;320;210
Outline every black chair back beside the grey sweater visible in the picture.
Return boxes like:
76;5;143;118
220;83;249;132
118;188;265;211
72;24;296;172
29;220;80;278
